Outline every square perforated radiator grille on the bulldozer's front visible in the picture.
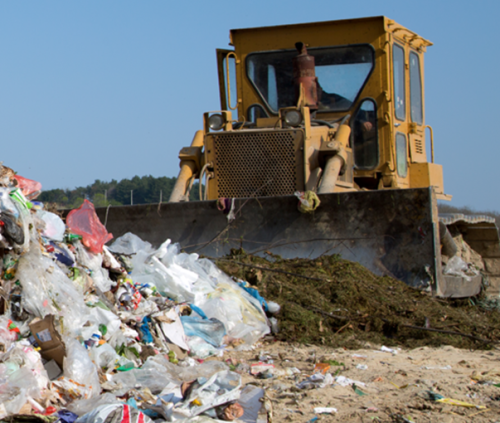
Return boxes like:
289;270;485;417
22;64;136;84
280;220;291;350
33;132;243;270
213;131;302;197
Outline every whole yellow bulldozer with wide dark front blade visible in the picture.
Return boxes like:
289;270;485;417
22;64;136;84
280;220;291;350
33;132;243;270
95;16;500;297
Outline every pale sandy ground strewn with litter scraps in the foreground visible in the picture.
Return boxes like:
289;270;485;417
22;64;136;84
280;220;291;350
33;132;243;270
224;341;500;422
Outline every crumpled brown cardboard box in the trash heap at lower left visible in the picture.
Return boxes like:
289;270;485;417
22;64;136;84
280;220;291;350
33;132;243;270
30;314;66;369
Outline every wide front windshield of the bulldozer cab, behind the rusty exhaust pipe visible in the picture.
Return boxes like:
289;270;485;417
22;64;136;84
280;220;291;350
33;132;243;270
246;44;375;113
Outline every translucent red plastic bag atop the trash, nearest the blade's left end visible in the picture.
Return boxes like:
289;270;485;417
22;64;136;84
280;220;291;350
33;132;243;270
66;200;113;254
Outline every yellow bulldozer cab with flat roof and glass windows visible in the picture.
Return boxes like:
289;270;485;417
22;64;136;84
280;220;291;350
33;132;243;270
217;16;450;199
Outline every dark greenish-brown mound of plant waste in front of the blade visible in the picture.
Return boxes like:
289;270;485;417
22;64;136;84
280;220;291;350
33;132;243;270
216;250;500;350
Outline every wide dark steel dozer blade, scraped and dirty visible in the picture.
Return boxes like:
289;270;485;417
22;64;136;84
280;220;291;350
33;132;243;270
97;188;452;293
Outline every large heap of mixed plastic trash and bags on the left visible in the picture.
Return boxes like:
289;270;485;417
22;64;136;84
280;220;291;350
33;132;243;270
0;166;279;422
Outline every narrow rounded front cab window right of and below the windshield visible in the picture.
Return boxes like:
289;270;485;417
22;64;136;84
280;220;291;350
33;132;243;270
351;99;378;169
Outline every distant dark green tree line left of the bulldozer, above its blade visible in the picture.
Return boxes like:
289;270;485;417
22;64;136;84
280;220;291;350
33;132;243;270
37;175;199;209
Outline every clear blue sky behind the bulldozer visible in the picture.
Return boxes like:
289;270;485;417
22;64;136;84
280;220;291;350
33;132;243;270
0;0;500;211
